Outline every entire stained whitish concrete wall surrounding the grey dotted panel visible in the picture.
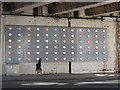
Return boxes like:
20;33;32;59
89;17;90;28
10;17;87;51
2;16;116;75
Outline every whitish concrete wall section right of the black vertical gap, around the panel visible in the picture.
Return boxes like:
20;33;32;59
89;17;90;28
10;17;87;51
71;18;117;73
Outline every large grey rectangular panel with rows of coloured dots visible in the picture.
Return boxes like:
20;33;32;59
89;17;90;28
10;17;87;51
5;25;107;63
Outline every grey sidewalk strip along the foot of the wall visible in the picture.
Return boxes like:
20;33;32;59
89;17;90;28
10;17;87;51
2;73;118;81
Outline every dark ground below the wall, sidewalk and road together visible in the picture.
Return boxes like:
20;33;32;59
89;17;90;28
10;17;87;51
2;73;120;90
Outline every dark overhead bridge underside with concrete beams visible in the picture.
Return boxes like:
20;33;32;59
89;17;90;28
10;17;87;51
2;0;120;16
